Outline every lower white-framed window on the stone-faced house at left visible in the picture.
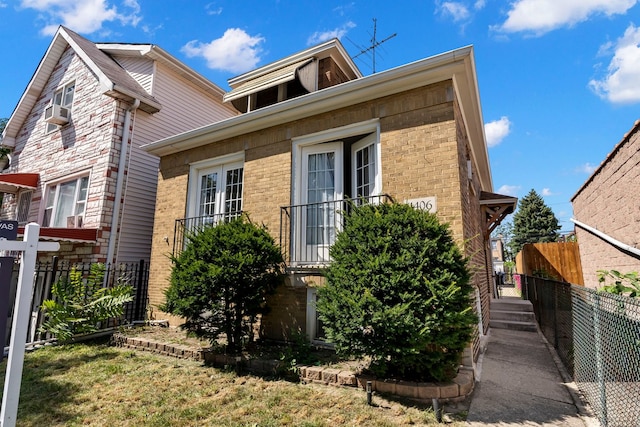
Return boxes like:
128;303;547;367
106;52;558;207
42;176;89;228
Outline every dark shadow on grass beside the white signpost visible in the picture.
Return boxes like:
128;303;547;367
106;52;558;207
0;340;119;425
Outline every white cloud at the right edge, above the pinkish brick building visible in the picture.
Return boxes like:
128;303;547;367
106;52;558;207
589;24;640;104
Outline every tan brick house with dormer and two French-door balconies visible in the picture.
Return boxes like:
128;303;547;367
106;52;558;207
143;40;515;362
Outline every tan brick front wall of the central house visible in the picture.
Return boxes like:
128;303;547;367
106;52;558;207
149;82;490;337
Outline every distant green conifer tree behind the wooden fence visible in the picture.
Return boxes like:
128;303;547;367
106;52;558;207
511;189;560;254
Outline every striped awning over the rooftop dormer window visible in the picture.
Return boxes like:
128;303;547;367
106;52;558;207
222;58;315;112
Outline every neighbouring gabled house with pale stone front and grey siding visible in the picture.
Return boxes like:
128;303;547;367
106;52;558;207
0;27;238;262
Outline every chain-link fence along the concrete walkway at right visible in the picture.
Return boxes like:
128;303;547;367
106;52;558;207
521;276;640;426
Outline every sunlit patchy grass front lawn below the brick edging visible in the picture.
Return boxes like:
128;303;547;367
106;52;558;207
0;342;464;427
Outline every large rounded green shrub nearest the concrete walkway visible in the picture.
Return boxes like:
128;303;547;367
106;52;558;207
317;204;477;381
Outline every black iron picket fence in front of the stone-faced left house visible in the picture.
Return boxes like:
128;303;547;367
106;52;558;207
3;257;149;352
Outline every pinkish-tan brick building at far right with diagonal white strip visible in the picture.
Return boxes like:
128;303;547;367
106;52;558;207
571;120;640;288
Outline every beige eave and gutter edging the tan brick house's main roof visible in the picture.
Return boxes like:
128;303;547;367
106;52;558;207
143;46;493;191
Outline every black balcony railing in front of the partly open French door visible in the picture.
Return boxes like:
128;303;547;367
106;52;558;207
280;194;392;270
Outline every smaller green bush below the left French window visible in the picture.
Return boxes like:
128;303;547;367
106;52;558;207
160;216;283;354
